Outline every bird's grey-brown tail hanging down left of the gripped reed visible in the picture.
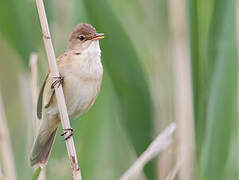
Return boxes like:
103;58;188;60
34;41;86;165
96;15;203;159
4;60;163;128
30;116;58;167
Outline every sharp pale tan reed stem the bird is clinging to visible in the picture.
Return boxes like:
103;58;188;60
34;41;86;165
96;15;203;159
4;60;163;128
36;0;81;180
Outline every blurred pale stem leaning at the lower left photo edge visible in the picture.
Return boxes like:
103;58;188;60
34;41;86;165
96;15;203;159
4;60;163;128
0;92;17;180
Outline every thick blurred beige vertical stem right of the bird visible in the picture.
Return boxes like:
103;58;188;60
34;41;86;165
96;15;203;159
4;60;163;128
170;0;195;180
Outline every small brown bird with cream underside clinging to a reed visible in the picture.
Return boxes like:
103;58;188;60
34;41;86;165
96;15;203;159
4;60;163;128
30;23;104;167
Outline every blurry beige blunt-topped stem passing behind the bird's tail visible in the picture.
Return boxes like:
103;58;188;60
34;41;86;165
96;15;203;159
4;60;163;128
29;53;46;180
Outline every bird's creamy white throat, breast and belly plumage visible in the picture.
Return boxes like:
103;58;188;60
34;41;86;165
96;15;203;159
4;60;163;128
47;42;103;117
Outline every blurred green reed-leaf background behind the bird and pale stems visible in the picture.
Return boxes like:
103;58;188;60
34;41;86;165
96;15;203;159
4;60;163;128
0;0;238;180
